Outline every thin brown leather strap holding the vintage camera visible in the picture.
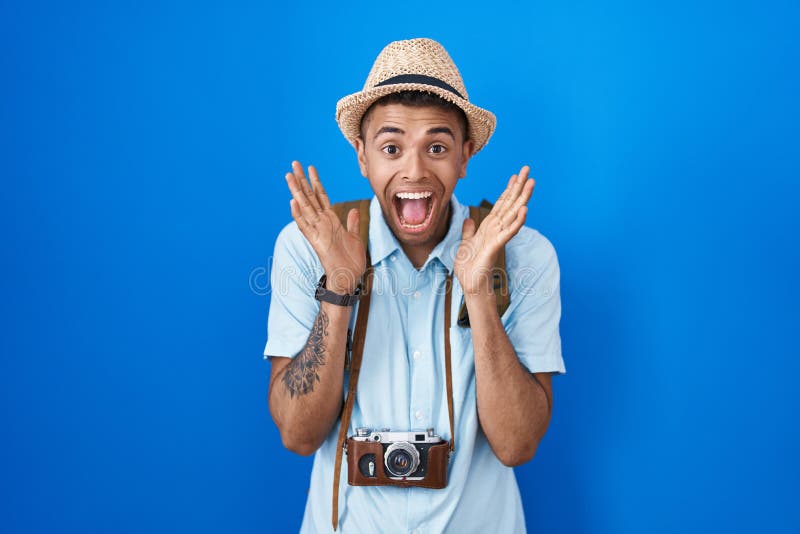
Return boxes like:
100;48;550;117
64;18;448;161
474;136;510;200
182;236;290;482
331;272;456;531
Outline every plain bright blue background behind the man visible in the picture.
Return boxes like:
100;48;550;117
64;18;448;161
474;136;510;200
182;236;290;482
0;1;800;533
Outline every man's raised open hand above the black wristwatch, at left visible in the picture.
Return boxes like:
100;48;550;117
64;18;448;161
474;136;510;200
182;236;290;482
286;161;367;294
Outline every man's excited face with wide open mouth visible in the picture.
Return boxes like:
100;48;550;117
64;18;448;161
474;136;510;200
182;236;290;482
356;104;473;257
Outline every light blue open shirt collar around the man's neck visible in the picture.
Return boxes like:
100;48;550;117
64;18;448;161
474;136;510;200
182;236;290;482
369;195;468;272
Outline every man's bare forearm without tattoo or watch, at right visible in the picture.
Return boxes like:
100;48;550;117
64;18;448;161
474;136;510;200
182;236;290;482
465;292;551;466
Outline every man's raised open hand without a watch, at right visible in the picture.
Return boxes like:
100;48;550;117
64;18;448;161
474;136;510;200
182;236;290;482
454;165;534;295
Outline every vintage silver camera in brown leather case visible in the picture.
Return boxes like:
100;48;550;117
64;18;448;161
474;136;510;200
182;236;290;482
347;428;450;489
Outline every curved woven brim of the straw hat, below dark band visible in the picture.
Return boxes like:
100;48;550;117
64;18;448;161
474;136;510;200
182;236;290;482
336;83;497;153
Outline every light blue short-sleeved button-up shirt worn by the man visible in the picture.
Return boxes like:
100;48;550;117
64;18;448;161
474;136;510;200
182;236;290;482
264;197;564;534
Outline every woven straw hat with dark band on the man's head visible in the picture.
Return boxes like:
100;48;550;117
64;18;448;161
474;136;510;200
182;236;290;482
336;39;496;152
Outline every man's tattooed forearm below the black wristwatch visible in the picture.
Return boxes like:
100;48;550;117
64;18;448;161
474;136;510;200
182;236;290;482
269;302;351;455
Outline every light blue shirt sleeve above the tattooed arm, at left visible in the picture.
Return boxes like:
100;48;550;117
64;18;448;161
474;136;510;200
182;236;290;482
264;222;323;359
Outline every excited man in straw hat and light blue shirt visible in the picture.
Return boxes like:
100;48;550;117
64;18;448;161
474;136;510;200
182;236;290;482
265;35;564;533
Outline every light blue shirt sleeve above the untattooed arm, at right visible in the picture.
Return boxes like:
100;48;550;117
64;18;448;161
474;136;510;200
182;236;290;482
503;227;566;373
